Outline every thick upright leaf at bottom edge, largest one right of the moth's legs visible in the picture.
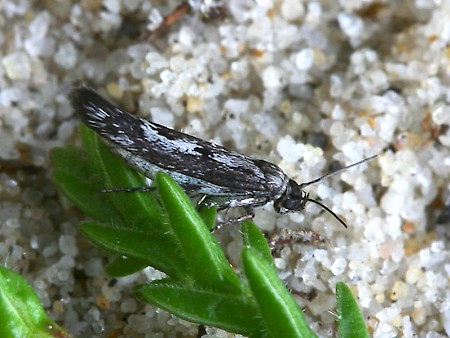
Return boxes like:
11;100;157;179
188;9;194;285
242;247;316;338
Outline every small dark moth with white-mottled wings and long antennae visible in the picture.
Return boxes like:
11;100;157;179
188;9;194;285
71;87;376;227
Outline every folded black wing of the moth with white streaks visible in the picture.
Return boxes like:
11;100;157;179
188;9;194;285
72;87;286;197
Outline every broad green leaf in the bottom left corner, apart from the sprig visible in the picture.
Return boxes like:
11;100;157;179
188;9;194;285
0;266;69;338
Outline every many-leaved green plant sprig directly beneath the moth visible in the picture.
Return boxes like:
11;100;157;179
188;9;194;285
46;126;370;337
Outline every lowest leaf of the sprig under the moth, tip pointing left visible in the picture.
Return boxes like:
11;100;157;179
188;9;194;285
134;280;265;337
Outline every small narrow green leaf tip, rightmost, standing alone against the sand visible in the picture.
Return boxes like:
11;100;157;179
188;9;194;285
336;282;369;338
